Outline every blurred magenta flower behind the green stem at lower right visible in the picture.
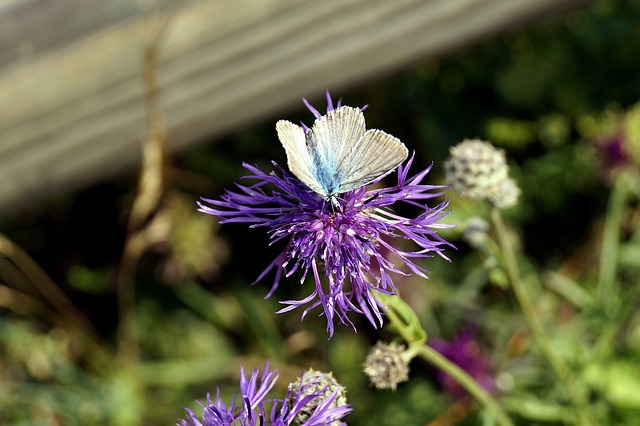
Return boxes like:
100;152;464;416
431;327;496;399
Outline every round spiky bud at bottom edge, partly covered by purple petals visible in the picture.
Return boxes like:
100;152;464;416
287;368;347;426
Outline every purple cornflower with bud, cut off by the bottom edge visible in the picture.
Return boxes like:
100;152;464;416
178;363;351;426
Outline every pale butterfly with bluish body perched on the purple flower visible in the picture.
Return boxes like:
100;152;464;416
276;106;409;202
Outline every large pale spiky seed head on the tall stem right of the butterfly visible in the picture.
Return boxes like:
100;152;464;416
444;139;520;208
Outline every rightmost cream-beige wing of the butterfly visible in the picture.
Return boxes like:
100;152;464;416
339;129;409;192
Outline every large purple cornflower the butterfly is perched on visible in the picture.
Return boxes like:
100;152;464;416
198;92;451;336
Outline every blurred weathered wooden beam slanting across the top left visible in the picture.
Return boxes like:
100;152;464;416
0;0;592;214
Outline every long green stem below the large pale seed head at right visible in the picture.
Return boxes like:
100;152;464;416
491;208;591;425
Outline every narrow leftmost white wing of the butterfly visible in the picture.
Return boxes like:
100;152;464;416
276;120;328;197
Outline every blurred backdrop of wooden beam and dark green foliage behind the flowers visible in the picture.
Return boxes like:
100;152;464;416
0;0;640;425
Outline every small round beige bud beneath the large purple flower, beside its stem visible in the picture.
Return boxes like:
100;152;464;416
363;342;409;390
